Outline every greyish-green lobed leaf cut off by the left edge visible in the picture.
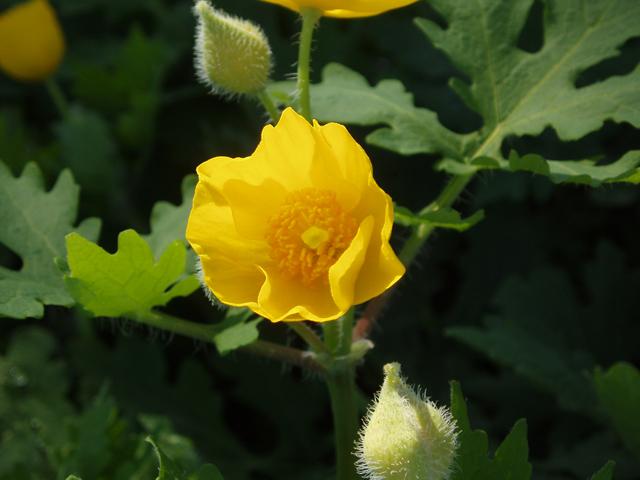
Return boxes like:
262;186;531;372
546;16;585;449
0;162;100;318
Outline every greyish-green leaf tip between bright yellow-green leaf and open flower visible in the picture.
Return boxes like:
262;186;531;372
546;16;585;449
140;175;198;260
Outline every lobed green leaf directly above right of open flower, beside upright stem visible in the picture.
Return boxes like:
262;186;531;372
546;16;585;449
311;63;467;160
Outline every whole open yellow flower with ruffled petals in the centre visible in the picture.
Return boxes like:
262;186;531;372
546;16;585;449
187;108;404;322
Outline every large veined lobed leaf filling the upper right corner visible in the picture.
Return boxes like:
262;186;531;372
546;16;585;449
417;0;640;143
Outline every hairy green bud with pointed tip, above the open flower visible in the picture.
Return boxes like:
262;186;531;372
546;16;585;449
194;0;272;96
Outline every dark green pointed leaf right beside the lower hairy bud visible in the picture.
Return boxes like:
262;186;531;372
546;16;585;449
451;381;531;480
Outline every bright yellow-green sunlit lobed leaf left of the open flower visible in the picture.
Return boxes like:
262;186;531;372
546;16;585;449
64;230;200;318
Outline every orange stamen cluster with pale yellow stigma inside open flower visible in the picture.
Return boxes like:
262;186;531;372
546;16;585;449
265;188;358;288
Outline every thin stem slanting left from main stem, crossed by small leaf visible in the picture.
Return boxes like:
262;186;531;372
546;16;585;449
134;310;326;373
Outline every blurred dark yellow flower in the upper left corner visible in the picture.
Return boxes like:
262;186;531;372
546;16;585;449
0;0;65;82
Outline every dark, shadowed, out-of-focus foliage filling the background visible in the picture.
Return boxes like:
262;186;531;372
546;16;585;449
0;0;640;480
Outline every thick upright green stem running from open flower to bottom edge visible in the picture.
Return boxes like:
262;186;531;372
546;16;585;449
322;308;360;480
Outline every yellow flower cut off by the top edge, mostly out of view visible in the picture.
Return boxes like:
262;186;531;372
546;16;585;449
263;0;417;18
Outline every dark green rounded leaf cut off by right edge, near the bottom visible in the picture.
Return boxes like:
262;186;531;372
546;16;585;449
594;362;640;459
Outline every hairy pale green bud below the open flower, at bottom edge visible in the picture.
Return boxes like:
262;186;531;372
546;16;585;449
356;363;458;480
